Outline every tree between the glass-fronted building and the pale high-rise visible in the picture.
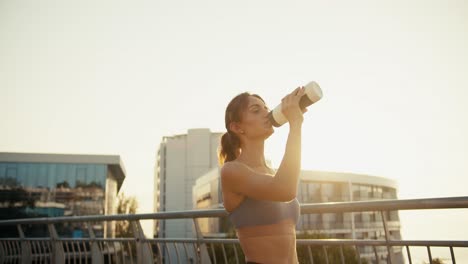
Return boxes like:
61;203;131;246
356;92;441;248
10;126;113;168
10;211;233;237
115;192;138;237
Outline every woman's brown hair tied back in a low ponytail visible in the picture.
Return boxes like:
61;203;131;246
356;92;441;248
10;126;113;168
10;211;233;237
218;92;265;165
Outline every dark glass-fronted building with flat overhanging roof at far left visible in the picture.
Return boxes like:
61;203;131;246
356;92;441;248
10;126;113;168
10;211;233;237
0;152;125;237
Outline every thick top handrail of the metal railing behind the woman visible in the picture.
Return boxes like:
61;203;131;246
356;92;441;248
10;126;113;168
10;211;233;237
0;196;468;225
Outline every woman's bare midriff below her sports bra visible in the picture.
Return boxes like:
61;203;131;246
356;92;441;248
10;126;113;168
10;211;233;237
236;219;298;264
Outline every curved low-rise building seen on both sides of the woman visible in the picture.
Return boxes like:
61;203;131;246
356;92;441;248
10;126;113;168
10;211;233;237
193;168;403;263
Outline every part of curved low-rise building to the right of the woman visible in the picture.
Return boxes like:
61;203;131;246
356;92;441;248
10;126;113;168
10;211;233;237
297;171;403;263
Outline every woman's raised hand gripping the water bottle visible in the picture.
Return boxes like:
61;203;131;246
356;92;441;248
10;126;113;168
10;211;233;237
281;86;307;125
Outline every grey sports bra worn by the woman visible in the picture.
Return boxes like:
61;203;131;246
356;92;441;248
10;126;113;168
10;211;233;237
229;197;300;228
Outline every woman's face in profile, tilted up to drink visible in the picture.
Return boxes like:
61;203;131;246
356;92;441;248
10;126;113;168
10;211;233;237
240;96;274;139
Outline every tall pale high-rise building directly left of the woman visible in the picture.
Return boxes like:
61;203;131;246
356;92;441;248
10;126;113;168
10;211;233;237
154;129;222;237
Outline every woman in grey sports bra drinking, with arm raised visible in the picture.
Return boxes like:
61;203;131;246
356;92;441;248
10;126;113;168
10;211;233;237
219;87;305;264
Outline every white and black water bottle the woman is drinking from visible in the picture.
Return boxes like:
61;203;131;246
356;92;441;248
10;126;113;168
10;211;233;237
268;81;322;127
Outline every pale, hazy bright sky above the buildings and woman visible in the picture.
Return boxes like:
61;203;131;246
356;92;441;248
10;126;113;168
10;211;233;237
0;0;468;262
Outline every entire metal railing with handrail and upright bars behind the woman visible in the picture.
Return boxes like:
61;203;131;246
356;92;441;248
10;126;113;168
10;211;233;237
0;197;468;264
